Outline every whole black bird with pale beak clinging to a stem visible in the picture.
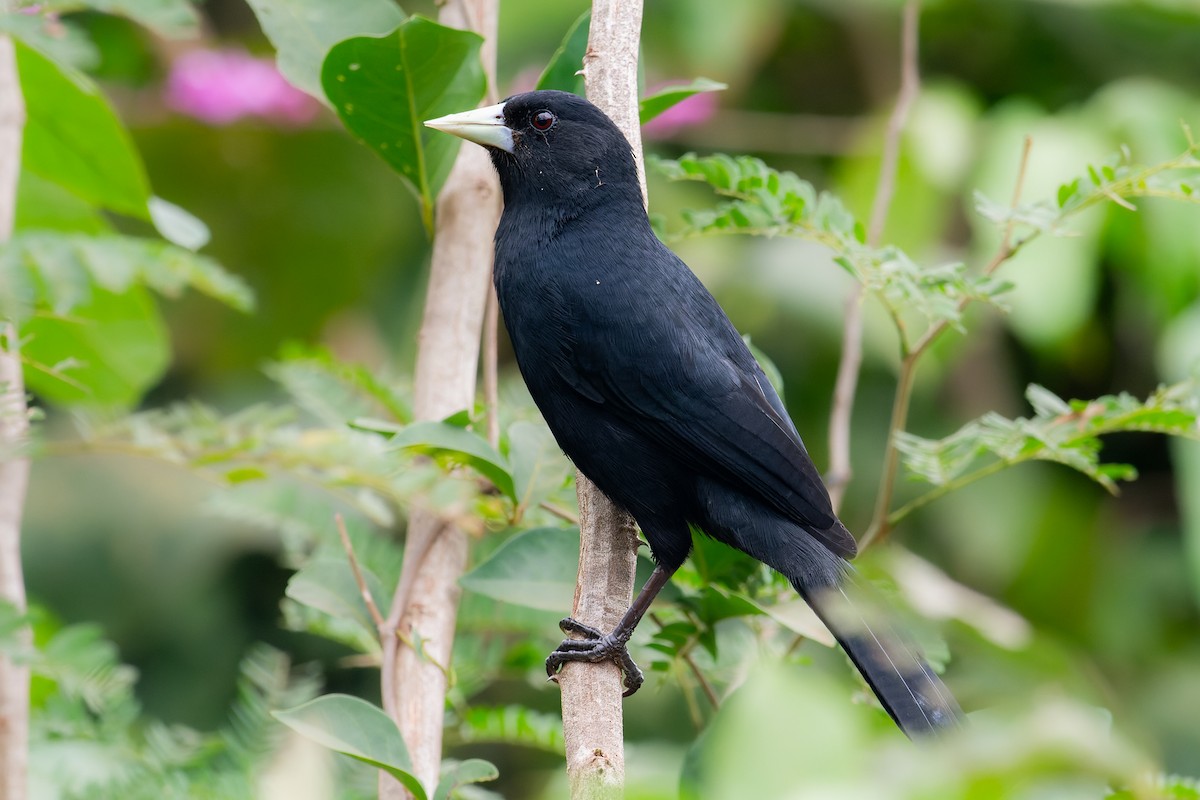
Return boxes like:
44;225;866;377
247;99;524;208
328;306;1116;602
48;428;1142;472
426;91;962;735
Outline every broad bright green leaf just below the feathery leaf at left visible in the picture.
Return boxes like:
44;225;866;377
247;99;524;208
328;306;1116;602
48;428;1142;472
20;287;170;405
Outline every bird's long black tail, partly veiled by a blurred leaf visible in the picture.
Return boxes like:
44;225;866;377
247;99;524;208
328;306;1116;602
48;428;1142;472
792;565;962;738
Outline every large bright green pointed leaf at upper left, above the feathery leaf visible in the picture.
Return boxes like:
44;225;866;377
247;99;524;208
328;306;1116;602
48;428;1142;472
17;43;150;219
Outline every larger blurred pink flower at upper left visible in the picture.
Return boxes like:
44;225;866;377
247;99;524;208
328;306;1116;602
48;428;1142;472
164;50;320;125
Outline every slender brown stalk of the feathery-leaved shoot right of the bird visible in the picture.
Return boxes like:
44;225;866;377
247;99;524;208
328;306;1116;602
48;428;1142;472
859;137;1033;549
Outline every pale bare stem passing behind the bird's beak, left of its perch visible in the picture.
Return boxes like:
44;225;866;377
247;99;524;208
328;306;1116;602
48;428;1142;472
379;0;500;800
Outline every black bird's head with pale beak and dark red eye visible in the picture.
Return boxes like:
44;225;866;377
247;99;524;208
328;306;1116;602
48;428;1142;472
426;91;642;205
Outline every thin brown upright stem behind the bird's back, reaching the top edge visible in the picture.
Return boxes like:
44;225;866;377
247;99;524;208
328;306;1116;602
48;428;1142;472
826;0;920;512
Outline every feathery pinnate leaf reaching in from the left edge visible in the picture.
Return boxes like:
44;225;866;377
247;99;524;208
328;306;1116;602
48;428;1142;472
0;233;253;320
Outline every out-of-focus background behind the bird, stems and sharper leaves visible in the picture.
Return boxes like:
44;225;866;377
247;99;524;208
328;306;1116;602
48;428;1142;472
16;0;1200;796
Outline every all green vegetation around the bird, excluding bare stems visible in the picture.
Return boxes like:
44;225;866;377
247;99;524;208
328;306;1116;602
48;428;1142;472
0;0;1200;800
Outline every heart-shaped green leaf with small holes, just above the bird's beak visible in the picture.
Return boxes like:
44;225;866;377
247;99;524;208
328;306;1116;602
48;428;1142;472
322;17;486;236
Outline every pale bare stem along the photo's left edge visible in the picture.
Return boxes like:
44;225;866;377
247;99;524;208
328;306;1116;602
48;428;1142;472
0;18;32;800
